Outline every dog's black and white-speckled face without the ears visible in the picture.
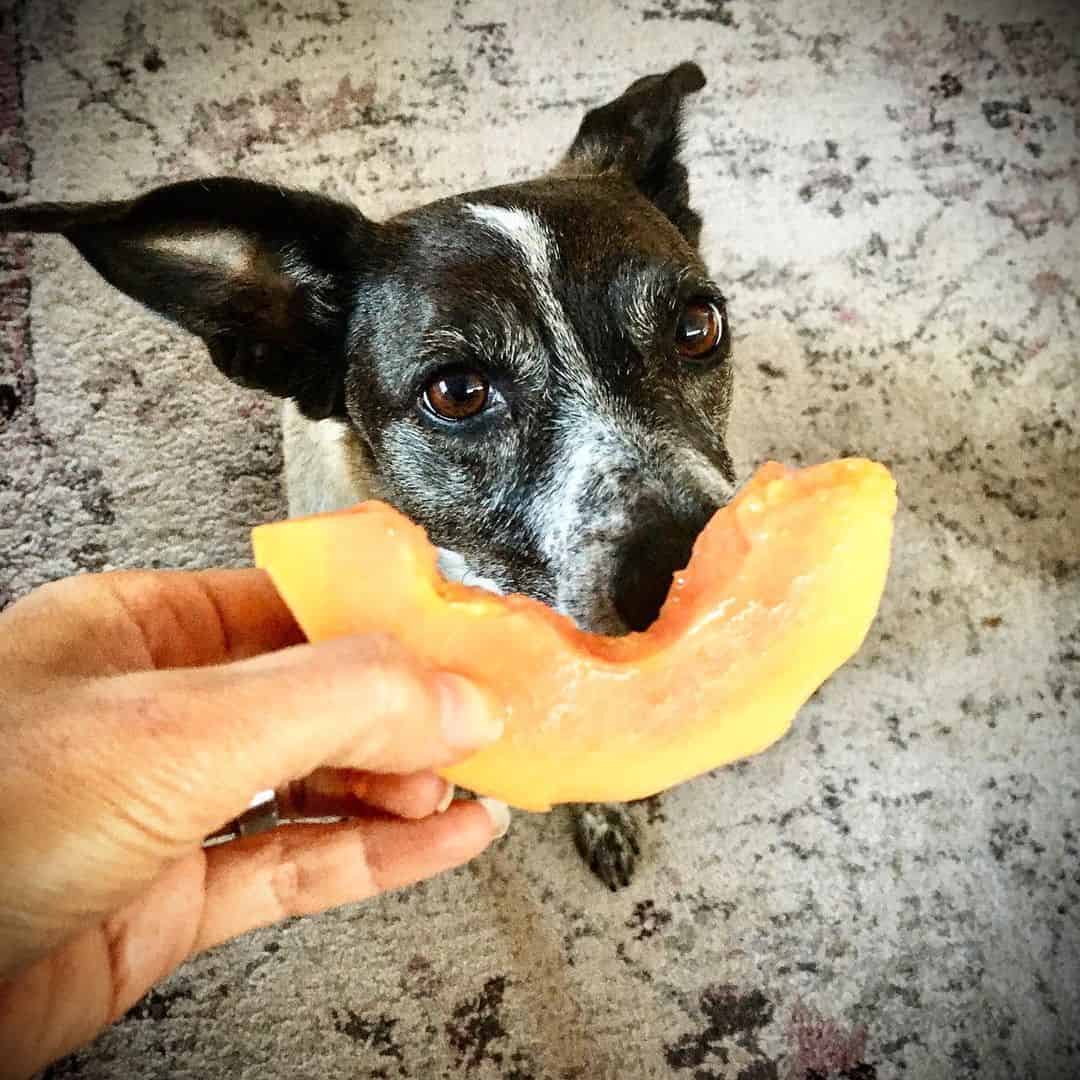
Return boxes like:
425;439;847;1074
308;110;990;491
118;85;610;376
345;178;731;632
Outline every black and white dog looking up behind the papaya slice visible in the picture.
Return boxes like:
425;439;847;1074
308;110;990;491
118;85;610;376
0;62;734;889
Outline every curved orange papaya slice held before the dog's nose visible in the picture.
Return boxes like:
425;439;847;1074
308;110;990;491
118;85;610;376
253;459;896;811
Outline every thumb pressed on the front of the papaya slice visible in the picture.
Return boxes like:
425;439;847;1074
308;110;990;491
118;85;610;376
81;635;502;843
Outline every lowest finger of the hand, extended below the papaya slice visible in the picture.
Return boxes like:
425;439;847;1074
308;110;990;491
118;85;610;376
192;801;509;953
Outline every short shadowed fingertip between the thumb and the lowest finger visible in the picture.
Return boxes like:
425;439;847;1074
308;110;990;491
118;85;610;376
278;769;454;819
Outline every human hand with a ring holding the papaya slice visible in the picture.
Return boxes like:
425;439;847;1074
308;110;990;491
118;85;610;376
0;570;509;1076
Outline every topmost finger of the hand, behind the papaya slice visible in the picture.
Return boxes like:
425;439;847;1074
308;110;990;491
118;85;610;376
4;570;303;676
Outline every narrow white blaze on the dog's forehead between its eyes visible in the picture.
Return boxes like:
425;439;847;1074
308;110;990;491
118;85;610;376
465;203;589;380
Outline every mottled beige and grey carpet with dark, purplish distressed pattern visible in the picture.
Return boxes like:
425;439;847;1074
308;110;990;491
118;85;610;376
0;0;1080;1080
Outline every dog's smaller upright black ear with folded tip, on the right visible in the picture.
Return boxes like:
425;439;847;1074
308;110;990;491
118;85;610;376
557;62;705;246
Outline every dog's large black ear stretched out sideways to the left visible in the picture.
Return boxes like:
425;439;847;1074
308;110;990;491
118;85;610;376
0;178;377;419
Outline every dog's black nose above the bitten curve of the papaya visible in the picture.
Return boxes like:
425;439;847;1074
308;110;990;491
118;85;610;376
615;518;704;631
